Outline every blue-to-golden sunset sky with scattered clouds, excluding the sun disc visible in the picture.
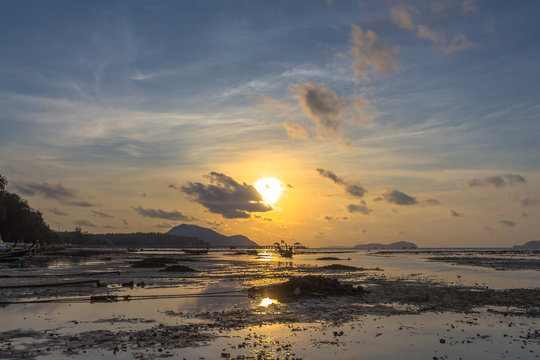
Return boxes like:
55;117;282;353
0;0;540;247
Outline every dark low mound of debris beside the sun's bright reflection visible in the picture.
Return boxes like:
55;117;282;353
248;275;364;301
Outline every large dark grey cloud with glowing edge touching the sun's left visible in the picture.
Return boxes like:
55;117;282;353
182;172;273;219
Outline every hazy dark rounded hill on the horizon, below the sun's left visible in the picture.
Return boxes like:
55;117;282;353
167;224;259;247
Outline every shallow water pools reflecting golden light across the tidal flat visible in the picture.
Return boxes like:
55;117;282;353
0;252;540;359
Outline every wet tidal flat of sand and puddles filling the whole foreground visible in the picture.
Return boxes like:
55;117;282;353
0;251;540;359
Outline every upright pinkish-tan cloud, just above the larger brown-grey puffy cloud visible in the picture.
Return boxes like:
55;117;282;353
349;25;398;79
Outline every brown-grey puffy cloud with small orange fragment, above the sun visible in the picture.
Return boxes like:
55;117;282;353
285;80;373;139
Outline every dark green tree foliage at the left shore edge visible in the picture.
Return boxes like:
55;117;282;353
0;175;53;243
